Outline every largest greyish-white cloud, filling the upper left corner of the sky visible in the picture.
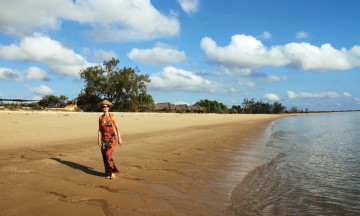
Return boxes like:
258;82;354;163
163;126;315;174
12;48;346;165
0;0;180;41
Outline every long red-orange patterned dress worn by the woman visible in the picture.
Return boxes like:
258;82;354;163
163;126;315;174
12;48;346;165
99;114;119;175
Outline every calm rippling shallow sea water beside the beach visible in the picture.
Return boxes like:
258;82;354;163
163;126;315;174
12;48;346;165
225;112;360;215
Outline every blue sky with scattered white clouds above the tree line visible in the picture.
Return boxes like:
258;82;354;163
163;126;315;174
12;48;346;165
0;0;360;111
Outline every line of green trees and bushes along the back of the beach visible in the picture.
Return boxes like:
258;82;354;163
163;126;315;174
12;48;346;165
29;58;301;114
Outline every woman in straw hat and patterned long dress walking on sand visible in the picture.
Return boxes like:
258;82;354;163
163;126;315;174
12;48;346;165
98;100;122;179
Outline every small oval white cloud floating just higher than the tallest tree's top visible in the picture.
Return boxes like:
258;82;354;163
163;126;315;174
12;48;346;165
128;43;186;65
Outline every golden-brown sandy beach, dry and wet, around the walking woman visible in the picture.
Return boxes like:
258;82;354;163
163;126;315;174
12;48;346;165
0;111;284;216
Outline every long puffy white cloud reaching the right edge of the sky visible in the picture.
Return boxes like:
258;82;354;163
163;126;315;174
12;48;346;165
200;35;360;72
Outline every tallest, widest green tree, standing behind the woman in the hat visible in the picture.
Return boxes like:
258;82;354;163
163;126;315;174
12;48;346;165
80;58;150;111
